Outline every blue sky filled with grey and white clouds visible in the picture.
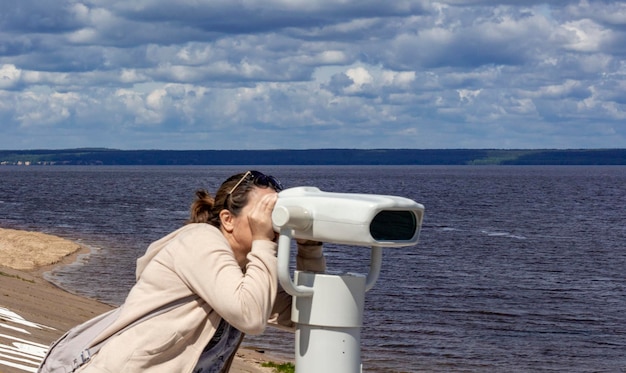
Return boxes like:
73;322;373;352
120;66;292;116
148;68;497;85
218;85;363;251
0;0;626;149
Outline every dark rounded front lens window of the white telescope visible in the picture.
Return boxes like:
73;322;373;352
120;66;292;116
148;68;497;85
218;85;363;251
370;210;417;241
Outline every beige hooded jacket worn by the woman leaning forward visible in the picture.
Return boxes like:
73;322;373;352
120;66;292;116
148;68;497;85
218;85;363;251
78;223;325;373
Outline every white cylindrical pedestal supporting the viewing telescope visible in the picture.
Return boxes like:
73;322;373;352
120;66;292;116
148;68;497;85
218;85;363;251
291;271;366;373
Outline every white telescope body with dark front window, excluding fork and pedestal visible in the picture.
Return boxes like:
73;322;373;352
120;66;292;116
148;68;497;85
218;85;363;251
272;187;424;247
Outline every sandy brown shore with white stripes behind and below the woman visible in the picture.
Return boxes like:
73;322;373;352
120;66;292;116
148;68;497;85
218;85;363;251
0;228;279;373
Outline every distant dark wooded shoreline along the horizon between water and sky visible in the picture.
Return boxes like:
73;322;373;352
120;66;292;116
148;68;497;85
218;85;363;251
0;148;626;166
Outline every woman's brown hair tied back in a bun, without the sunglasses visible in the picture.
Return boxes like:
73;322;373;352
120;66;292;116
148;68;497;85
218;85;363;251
186;173;258;228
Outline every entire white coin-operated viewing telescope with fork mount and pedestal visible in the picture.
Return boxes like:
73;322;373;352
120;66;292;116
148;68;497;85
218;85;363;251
272;187;424;373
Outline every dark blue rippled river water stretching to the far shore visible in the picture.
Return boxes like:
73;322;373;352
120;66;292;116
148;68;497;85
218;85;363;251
0;166;626;372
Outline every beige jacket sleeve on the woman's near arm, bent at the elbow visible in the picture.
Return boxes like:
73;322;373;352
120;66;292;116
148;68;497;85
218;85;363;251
174;230;278;334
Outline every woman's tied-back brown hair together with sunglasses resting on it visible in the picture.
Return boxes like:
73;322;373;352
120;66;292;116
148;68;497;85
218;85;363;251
187;170;283;228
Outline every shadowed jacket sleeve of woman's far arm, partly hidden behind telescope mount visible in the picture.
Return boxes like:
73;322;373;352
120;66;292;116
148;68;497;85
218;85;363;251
269;244;326;330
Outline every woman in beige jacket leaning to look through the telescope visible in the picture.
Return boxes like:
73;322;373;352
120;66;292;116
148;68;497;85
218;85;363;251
78;171;325;373
